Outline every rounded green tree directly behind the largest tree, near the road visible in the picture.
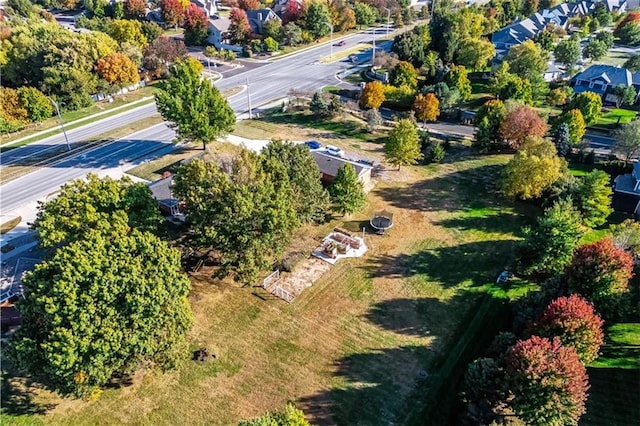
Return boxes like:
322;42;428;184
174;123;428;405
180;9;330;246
33;174;162;248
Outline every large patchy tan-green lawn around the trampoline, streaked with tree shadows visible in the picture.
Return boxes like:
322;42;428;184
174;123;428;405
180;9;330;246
1;115;533;425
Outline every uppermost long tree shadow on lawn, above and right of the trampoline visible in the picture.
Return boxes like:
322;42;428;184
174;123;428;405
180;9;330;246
375;165;502;215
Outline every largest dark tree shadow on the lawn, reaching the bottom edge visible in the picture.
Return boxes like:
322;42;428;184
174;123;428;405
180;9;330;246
298;292;504;425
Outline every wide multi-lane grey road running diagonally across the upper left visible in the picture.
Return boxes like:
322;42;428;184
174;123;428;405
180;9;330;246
0;26;391;214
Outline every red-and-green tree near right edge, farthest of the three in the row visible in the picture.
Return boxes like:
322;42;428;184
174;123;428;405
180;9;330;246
565;238;633;320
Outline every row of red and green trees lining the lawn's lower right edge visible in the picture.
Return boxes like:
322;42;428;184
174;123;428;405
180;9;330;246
465;199;638;424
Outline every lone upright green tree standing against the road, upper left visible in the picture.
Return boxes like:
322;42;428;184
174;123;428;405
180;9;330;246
155;58;236;147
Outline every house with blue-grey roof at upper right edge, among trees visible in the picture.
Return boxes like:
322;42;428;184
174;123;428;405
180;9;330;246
570;64;640;104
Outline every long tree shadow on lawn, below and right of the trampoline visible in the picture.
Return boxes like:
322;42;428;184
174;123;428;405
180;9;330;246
363;240;515;287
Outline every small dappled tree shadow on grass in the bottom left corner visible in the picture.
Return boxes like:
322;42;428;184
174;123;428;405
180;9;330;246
0;368;55;416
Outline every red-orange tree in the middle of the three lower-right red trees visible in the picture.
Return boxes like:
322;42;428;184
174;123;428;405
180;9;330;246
532;294;604;364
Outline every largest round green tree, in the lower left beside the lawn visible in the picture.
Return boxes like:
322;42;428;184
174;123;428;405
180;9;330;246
9;229;192;396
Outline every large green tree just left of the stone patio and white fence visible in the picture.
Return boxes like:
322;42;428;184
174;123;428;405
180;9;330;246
174;154;299;283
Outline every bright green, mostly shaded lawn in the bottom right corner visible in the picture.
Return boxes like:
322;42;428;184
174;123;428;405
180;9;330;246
581;323;640;426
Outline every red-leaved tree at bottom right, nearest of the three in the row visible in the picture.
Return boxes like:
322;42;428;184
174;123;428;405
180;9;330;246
505;336;589;425
